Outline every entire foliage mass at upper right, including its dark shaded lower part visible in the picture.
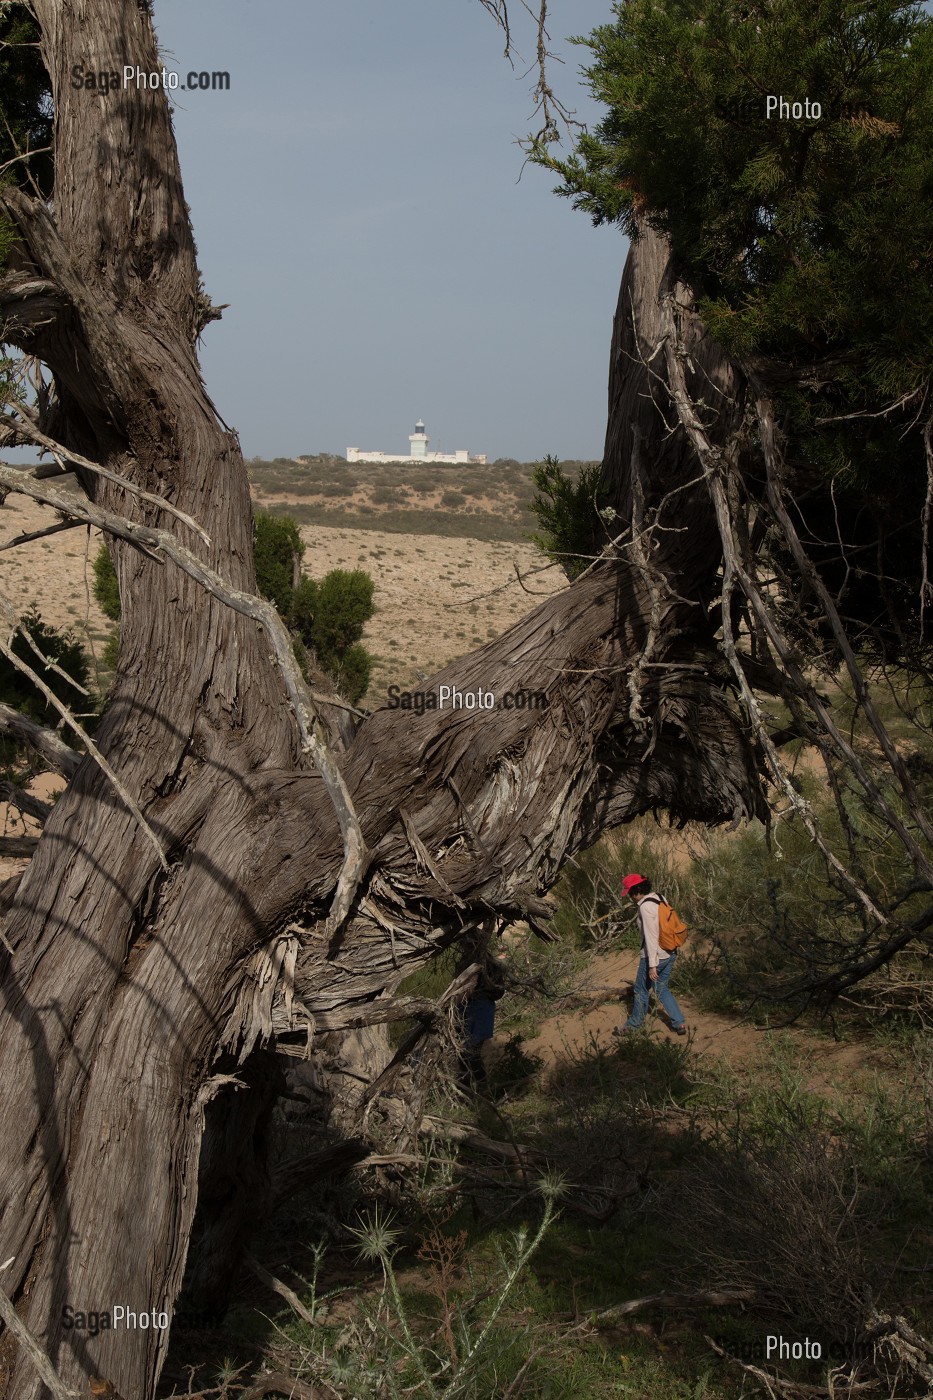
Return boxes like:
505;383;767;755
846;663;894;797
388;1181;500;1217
532;0;933;657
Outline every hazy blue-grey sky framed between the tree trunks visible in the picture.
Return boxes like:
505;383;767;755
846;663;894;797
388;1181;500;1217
156;0;626;459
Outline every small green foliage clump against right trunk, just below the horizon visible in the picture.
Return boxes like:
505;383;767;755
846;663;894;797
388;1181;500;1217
531;456;605;578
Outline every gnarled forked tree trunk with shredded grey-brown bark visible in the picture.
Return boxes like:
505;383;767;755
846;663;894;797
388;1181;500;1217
0;0;761;1400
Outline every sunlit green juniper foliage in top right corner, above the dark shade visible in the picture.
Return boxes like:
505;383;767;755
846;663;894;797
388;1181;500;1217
540;0;933;395
